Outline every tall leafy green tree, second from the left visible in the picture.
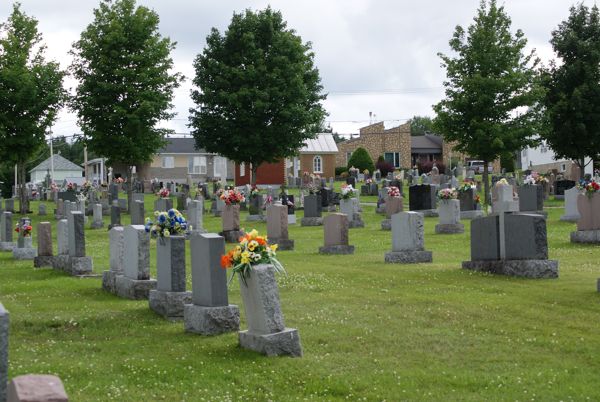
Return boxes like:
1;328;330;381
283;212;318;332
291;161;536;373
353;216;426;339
71;0;183;180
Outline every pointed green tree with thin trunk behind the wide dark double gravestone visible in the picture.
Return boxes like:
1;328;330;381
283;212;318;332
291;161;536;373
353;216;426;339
434;0;543;204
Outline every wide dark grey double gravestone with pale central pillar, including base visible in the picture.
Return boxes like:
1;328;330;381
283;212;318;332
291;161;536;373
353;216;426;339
462;213;558;278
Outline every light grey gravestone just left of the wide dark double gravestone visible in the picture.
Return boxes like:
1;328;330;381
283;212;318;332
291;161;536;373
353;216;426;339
385;211;432;264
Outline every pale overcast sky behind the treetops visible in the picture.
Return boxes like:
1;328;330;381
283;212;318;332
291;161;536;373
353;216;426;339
0;0;593;135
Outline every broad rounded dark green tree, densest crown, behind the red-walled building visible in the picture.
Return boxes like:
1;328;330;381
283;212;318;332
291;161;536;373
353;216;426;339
190;8;325;182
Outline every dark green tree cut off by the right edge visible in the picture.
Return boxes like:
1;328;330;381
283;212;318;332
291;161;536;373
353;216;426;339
542;4;600;177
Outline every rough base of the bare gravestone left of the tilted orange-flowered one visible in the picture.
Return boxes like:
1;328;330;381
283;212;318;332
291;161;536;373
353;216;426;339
183;304;240;336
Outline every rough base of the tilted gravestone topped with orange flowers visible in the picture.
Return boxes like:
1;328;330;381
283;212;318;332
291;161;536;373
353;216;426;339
239;328;302;357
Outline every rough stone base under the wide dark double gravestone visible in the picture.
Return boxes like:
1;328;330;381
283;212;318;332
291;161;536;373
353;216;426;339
462;260;558;279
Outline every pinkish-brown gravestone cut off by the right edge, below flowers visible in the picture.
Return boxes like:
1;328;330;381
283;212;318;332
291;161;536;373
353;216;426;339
571;187;600;244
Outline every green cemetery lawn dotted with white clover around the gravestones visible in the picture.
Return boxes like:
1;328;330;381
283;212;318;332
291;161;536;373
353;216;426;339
0;196;600;401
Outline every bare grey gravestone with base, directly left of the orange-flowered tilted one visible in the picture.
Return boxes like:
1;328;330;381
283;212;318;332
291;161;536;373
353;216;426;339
183;233;240;335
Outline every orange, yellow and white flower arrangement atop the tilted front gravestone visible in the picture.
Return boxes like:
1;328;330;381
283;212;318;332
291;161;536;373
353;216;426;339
221;229;285;285
